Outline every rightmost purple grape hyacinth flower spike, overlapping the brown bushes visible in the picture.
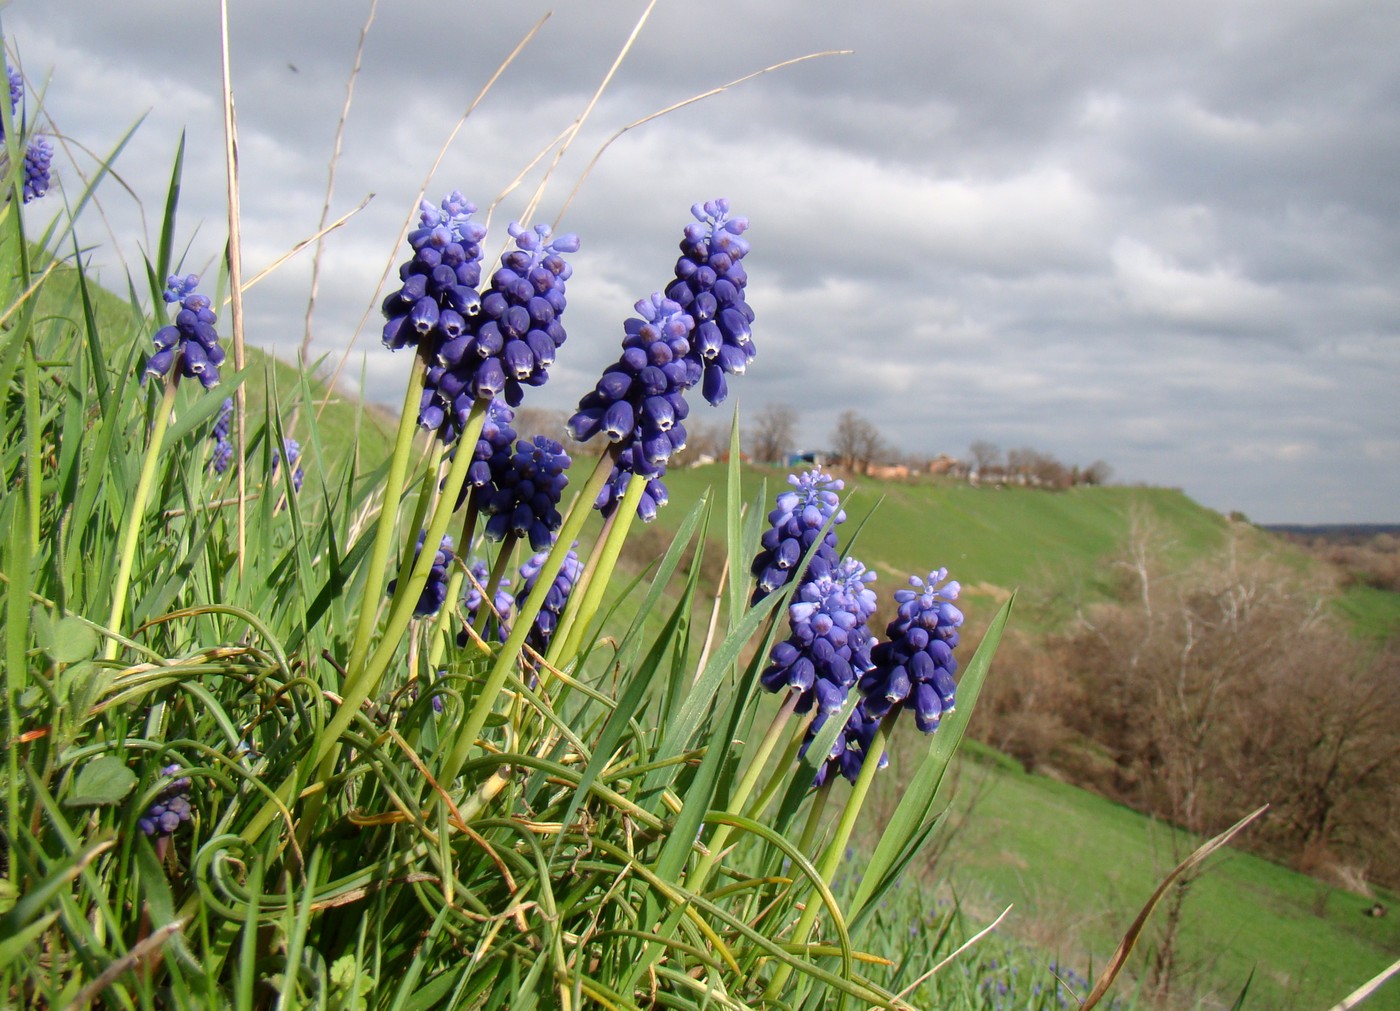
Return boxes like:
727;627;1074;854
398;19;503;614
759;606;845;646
860;569;963;734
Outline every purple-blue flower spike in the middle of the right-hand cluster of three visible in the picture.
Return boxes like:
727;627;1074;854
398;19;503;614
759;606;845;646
759;559;875;716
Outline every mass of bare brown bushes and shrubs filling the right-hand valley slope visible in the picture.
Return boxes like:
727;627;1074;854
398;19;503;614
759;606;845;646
973;520;1400;886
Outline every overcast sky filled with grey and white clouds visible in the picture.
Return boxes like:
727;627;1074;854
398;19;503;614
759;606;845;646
0;0;1400;522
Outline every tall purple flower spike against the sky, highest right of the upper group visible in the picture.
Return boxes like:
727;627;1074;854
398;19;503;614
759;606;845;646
666;197;755;406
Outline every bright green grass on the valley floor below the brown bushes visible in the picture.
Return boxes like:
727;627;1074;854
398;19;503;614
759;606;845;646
907;744;1400;1010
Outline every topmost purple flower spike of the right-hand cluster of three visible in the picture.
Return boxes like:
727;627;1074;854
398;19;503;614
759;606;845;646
749;466;846;606
